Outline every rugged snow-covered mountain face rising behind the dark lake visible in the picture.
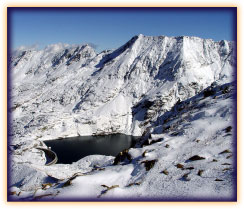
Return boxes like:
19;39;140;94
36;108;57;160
9;35;236;140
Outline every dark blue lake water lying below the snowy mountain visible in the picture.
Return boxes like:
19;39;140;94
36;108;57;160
44;134;139;164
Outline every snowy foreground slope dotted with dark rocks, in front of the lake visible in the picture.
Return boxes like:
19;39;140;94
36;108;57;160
10;83;236;201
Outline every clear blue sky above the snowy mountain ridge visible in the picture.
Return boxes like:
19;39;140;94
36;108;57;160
8;8;236;52
